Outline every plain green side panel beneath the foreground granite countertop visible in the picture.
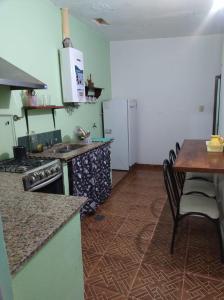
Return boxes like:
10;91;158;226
12;213;84;300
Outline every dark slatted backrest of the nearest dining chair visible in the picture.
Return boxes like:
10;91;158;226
163;159;180;220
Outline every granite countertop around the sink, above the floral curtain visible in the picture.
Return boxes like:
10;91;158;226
29;141;111;161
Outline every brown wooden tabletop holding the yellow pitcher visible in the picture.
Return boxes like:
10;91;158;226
174;140;224;173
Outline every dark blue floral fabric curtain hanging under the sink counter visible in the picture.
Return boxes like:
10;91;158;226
72;144;112;217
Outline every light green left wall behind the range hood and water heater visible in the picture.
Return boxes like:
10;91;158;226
0;0;111;148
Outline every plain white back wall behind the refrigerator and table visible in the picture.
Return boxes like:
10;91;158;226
111;35;222;164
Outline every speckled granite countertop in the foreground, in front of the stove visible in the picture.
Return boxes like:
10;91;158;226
0;173;87;275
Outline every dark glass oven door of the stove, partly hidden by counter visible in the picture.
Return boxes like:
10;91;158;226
30;173;64;194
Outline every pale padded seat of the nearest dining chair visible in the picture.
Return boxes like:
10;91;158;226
180;194;219;219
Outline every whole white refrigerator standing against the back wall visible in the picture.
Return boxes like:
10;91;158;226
103;100;137;170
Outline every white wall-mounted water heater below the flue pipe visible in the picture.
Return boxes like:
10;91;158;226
60;47;86;103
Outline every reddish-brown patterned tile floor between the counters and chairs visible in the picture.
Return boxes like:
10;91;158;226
82;169;224;300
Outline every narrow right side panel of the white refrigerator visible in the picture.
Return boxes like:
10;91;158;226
128;100;137;167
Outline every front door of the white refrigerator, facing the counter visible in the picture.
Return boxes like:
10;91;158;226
103;100;129;170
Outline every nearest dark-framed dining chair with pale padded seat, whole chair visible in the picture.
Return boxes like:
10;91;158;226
163;159;224;262
